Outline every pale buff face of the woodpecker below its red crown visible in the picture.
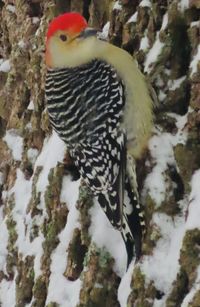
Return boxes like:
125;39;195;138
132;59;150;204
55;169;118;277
46;31;98;68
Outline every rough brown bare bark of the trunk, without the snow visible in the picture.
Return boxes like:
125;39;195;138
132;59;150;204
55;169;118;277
0;0;200;307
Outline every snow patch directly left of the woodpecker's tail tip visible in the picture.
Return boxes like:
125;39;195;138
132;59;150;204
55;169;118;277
89;200;127;277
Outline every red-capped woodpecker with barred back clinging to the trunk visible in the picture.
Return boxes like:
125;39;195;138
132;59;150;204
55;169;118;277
45;12;153;265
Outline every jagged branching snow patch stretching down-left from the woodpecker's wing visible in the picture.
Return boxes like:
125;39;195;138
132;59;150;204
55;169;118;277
5;133;68;278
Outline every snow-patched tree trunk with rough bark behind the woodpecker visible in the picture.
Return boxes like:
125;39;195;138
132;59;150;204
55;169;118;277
0;0;200;307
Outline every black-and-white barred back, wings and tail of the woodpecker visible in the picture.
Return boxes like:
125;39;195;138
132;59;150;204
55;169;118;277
46;59;143;263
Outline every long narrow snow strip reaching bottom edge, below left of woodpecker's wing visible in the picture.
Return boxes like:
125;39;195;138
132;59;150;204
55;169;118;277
46;176;81;307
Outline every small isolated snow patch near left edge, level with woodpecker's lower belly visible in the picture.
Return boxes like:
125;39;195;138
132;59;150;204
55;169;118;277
3;129;23;161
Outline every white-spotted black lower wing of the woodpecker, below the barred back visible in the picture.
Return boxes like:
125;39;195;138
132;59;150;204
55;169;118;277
71;128;126;229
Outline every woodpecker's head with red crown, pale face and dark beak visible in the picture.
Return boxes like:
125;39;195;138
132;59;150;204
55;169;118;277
45;13;97;68
